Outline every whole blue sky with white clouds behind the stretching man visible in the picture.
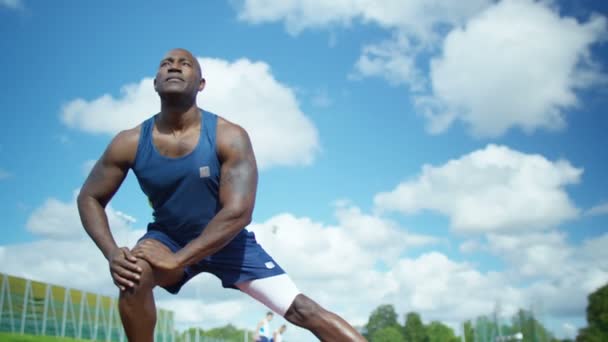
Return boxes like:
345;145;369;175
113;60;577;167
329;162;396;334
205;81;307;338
0;0;608;341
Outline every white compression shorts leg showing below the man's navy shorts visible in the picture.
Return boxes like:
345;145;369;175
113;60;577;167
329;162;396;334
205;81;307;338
235;273;300;317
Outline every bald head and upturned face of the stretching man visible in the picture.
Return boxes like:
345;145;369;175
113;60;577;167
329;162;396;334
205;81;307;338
154;49;205;96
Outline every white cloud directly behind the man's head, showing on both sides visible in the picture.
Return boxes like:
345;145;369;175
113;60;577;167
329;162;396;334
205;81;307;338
61;58;320;168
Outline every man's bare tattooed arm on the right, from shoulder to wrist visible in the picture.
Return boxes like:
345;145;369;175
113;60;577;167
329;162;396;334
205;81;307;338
176;120;258;266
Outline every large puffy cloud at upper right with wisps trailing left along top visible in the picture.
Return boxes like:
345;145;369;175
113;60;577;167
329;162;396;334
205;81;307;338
237;0;607;137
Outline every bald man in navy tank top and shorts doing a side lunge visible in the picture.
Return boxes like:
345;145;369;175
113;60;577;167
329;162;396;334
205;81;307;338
78;49;365;341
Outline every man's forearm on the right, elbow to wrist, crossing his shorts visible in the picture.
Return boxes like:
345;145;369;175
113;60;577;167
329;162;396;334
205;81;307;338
176;209;251;267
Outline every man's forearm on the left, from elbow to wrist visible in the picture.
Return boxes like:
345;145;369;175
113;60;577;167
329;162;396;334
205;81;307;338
77;194;118;259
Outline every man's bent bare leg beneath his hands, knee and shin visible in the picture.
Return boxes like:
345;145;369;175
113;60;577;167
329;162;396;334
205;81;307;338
118;242;183;342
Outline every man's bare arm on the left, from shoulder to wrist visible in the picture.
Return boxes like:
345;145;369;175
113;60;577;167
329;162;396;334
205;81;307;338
77;130;139;260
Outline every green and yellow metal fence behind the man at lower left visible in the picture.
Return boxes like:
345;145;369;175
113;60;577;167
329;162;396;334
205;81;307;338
0;273;175;342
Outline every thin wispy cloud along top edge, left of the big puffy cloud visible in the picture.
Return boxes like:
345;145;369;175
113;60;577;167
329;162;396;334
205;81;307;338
237;0;492;91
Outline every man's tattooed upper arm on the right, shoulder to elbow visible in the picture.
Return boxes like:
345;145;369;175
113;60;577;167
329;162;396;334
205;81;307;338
220;128;258;214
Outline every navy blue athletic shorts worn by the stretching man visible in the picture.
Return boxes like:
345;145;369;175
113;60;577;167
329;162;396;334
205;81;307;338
139;229;285;294
